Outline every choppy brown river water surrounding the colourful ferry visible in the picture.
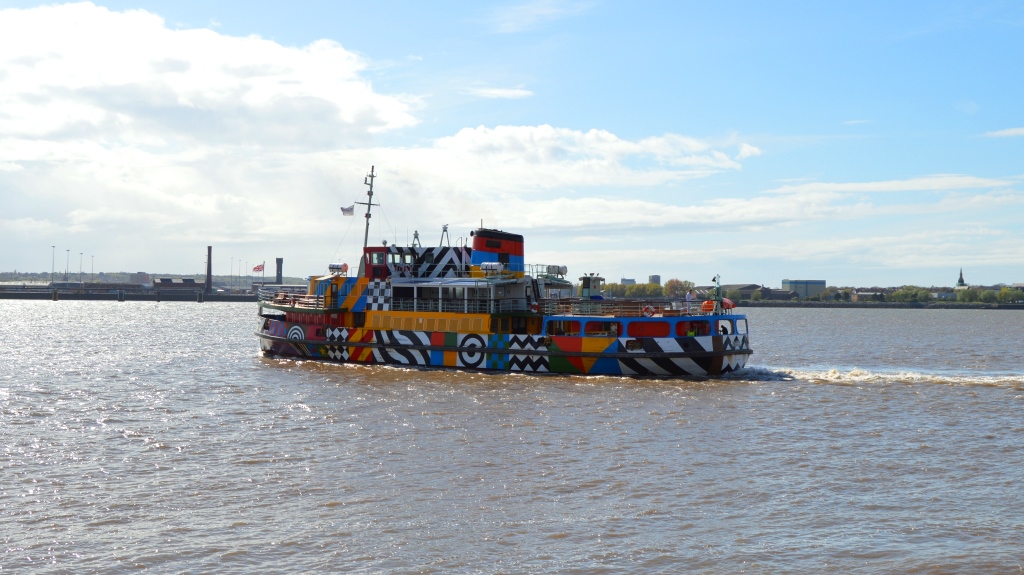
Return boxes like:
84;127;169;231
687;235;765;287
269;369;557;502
0;301;1024;573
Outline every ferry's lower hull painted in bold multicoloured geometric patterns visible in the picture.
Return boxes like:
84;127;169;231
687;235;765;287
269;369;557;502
257;319;751;377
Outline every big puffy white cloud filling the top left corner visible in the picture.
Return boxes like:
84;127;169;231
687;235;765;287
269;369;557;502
0;3;417;147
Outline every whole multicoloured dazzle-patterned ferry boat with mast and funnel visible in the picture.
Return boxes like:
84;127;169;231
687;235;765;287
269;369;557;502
256;168;752;378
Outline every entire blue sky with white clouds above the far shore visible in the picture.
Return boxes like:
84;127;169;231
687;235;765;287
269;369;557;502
0;0;1024;288
